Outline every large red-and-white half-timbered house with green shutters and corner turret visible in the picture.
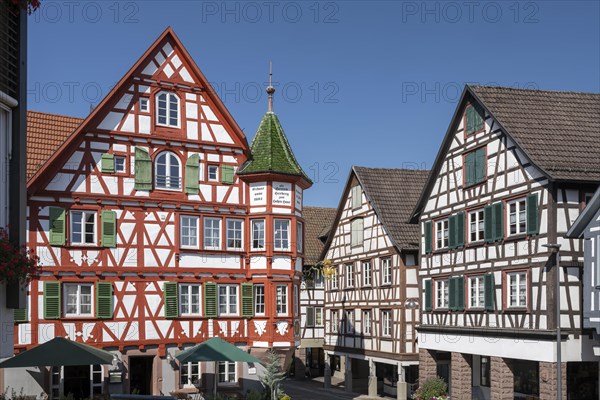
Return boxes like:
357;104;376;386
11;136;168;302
3;28;311;398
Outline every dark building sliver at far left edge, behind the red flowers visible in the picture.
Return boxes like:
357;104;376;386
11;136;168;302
0;1;27;360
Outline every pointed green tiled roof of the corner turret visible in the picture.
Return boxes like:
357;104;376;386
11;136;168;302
238;112;312;183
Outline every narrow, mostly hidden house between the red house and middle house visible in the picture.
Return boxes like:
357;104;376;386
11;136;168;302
294;207;336;378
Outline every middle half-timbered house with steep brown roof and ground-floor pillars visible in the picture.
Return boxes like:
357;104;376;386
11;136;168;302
322;167;427;399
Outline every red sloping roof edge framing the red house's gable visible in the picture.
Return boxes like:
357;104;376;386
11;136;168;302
27;26;247;192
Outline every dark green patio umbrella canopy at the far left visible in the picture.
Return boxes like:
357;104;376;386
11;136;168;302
0;337;113;368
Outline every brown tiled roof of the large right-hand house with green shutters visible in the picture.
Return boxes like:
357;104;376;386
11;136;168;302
411;85;600;223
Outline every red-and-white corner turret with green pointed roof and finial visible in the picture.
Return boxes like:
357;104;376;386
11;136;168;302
237;65;312;357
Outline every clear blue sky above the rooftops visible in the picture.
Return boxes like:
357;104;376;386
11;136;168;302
28;0;600;207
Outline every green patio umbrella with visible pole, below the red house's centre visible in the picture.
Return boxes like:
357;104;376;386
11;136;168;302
175;337;260;395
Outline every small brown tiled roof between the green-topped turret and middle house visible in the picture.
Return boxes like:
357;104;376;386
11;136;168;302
302;206;336;265
